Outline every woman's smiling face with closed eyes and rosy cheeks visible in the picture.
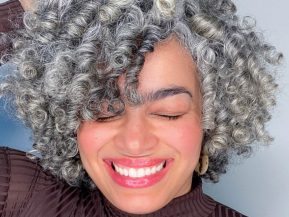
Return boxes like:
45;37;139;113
77;38;203;214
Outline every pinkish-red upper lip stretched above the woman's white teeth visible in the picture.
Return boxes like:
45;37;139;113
104;158;169;168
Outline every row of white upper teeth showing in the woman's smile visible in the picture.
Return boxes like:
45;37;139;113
113;161;165;178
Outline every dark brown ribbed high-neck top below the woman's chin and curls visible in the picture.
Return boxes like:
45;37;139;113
0;147;245;217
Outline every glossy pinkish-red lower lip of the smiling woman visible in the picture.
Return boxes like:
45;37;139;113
106;161;171;188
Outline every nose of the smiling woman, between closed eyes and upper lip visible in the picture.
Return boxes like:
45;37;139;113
114;111;158;157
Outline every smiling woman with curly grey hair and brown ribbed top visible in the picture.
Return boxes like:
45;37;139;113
0;0;281;216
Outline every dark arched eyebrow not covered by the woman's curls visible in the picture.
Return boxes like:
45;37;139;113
140;86;193;104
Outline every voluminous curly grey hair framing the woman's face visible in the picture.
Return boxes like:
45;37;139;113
0;0;282;185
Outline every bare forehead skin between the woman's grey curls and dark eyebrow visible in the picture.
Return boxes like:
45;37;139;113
119;36;200;103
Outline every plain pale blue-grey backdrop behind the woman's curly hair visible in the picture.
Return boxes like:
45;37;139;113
0;0;289;217
